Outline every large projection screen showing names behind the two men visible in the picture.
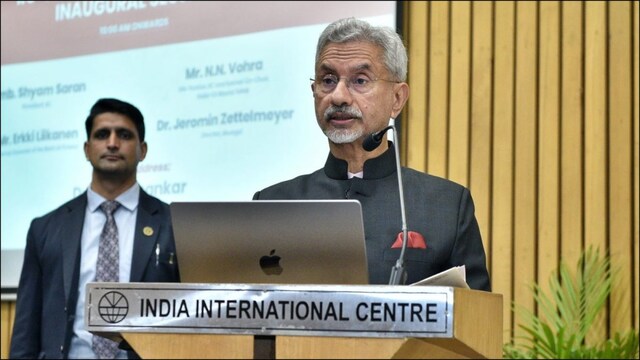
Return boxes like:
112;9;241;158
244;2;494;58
1;1;398;298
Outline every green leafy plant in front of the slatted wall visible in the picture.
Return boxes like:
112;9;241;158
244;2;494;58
503;247;639;359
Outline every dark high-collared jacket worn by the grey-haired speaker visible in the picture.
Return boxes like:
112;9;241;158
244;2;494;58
253;142;491;291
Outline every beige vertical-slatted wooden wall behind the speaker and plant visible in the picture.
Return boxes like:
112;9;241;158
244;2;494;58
0;1;640;358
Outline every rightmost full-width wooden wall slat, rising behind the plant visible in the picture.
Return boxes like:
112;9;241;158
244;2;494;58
607;2;633;332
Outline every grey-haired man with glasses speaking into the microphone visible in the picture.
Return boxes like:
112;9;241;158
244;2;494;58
253;18;491;291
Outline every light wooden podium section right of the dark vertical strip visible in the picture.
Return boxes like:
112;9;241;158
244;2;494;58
276;289;502;359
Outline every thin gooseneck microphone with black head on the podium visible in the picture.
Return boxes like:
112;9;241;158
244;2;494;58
362;118;409;285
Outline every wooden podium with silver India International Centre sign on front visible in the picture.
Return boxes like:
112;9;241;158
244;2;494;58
85;283;503;359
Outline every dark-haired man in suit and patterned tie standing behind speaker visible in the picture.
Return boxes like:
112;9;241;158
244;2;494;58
9;99;180;359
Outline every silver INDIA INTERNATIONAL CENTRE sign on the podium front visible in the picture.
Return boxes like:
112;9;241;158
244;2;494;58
85;283;454;338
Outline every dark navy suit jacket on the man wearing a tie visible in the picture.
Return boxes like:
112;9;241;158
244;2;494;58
9;189;180;359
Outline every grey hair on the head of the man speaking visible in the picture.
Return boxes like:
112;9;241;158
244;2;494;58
316;18;407;82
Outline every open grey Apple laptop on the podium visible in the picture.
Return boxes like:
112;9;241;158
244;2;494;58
170;200;369;285
